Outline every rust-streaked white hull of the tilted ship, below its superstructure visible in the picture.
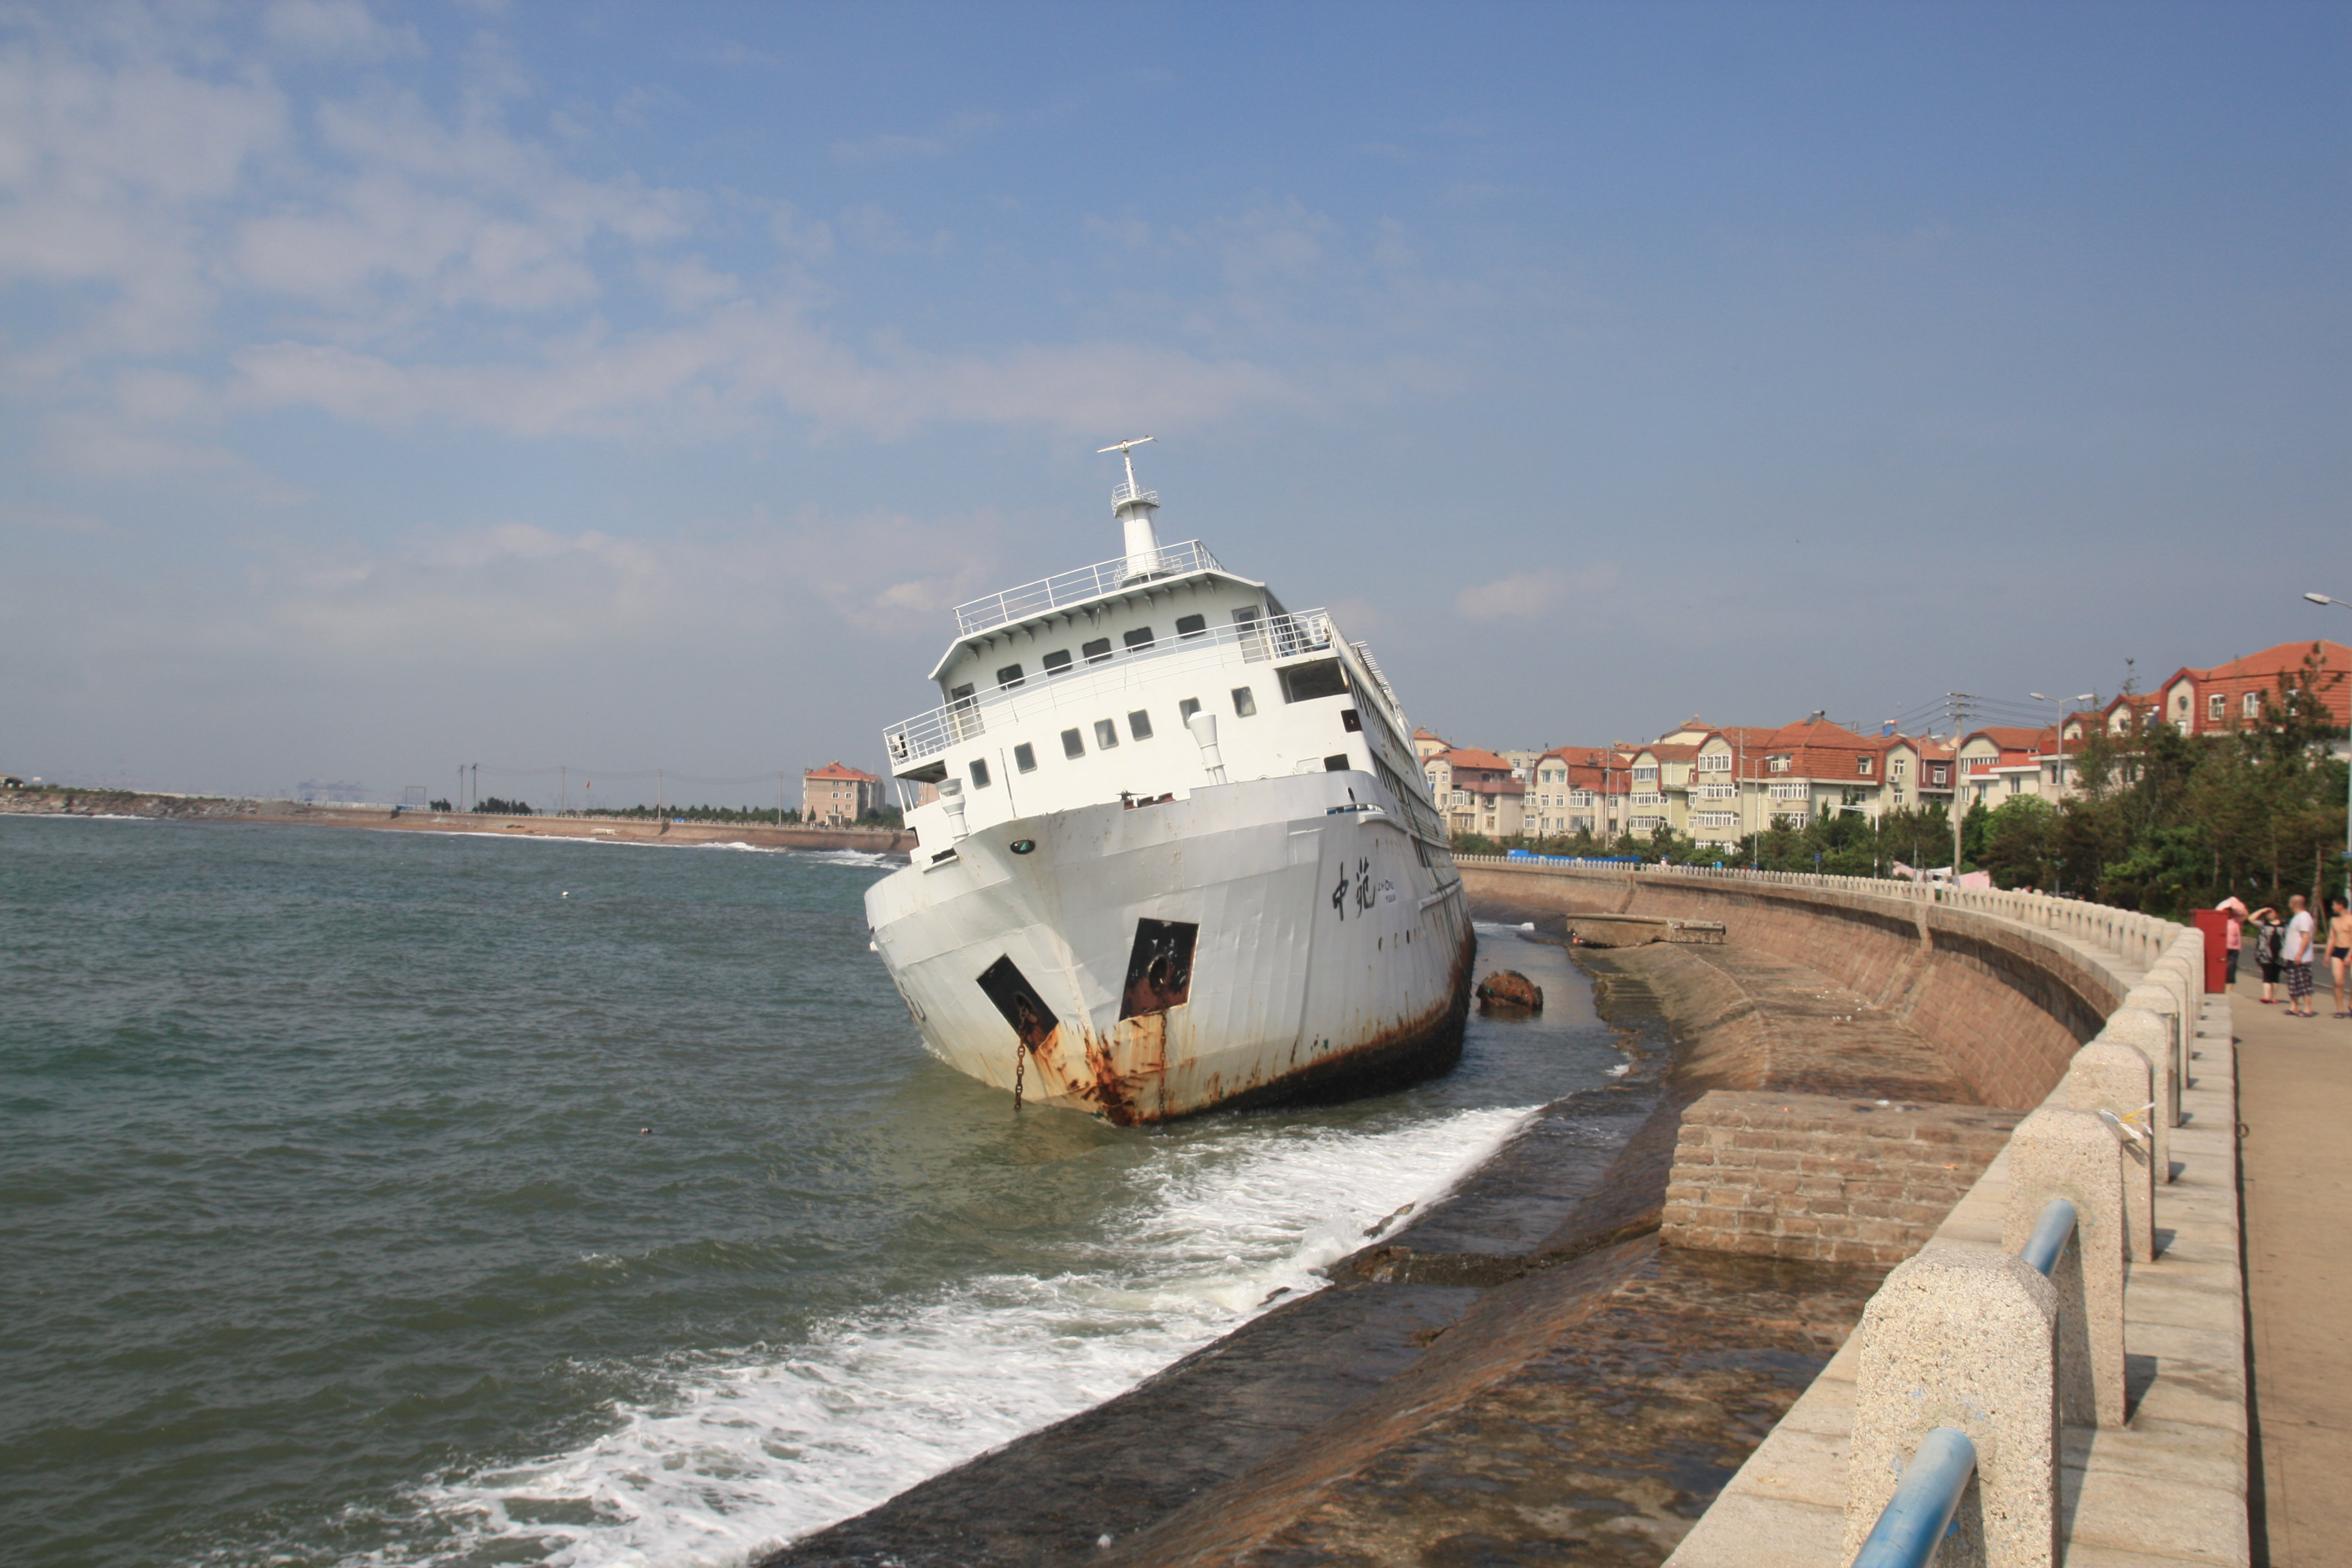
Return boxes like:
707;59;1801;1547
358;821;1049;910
865;771;1475;1126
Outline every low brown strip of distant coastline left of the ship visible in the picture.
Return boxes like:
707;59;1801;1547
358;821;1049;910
0;787;915;853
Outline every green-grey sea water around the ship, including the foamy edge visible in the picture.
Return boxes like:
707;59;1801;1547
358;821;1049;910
0;818;1623;1568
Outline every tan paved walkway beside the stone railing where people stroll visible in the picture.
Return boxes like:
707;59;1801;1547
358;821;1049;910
2230;966;2352;1568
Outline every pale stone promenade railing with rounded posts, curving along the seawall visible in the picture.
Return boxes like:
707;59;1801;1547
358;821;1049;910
1458;856;2251;1568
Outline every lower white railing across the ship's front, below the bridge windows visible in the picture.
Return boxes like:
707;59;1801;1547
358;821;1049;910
882;609;1336;774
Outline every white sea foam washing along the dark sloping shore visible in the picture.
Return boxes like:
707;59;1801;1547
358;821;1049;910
362;1109;1529;1568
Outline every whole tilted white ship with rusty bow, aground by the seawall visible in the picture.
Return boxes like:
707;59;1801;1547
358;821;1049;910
865;437;1475;1126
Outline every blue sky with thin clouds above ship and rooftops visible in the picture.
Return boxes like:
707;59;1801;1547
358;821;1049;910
0;0;2352;799
